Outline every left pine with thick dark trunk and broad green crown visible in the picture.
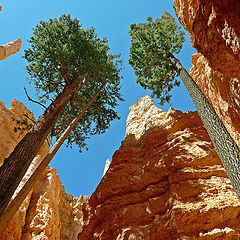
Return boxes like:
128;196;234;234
0;15;122;216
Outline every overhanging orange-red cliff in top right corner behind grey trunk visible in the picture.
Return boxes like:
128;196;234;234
173;0;240;146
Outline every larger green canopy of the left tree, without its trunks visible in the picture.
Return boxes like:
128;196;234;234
23;15;123;150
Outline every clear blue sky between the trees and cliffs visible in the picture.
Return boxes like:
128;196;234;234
0;0;195;196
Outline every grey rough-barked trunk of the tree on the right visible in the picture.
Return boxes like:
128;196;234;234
170;53;240;200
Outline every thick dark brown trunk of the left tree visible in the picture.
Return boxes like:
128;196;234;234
0;78;82;216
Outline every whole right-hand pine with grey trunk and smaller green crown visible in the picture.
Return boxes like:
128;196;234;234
129;12;240;199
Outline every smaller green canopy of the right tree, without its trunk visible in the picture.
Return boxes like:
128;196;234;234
129;12;184;105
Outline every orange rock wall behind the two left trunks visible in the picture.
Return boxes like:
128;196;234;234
0;100;86;240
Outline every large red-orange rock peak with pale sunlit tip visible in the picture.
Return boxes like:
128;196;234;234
78;96;240;240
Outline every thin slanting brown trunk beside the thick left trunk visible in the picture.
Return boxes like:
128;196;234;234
0;82;107;234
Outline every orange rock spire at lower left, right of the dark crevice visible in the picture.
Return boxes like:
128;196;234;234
21;168;84;240
